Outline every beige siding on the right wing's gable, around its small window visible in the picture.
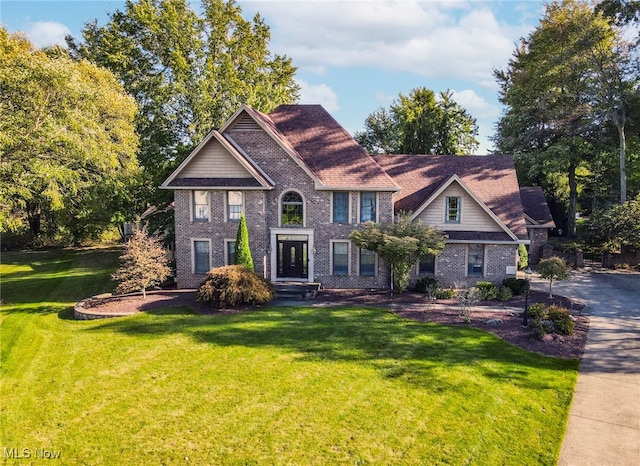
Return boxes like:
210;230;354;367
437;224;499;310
418;182;503;231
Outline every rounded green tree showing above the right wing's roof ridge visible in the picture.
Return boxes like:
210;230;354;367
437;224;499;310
355;87;478;155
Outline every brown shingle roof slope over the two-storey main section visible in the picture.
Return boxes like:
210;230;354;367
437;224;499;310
266;105;398;191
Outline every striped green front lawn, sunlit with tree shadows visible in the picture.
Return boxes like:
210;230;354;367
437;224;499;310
0;250;577;465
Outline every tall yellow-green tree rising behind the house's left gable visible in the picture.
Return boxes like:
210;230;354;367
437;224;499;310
67;0;299;222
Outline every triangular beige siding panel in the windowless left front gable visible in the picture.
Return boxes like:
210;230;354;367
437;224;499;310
180;139;252;178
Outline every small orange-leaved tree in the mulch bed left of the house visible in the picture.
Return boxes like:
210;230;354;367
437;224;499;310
111;230;171;299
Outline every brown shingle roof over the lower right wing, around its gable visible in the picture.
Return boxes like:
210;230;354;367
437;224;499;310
373;155;528;240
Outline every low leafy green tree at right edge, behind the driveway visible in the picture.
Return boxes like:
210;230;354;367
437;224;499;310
586;194;640;251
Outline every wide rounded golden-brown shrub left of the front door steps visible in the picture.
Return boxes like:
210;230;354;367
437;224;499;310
196;265;274;308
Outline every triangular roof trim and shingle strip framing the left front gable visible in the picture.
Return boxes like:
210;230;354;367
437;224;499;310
160;130;273;189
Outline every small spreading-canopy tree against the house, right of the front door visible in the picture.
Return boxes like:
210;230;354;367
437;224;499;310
350;213;445;293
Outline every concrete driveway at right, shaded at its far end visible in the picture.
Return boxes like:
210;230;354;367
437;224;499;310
531;270;640;466
